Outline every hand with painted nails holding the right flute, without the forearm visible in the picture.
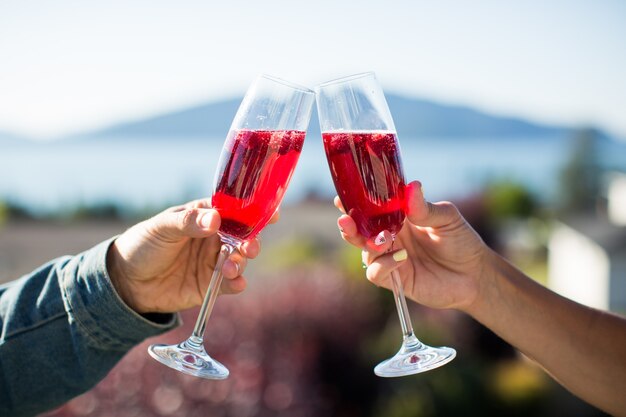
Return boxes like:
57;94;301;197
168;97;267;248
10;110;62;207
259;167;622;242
335;181;487;308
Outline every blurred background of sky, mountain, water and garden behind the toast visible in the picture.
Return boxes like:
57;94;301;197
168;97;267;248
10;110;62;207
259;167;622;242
0;0;626;417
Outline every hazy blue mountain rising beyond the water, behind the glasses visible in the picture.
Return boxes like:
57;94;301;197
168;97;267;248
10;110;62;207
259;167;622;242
73;94;584;140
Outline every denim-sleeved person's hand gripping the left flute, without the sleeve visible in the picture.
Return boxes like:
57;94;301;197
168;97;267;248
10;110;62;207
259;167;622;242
107;200;278;313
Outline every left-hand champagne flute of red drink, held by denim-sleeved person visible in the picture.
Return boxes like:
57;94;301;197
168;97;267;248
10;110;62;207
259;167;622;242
148;75;315;379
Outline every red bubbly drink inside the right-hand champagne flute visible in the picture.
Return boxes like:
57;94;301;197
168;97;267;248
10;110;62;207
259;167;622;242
322;131;406;238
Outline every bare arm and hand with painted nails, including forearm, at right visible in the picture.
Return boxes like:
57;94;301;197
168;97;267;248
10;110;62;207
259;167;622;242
335;182;626;415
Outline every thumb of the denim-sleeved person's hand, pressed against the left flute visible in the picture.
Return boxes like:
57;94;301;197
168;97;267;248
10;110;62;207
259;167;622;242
148;208;221;242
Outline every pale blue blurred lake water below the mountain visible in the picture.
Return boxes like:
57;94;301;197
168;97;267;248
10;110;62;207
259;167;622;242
0;137;626;212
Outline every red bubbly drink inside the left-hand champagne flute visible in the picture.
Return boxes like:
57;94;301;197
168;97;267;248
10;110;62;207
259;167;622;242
212;129;305;240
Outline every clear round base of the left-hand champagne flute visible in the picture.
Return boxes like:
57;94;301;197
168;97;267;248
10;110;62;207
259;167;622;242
148;340;229;379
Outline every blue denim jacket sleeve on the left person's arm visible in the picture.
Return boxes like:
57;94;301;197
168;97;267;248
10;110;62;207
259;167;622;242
0;239;179;416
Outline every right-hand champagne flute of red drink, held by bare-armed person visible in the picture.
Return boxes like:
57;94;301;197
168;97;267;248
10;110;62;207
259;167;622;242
316;72;456;377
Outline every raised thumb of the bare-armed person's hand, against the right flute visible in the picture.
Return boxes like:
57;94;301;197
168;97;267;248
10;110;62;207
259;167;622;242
406;181;461;227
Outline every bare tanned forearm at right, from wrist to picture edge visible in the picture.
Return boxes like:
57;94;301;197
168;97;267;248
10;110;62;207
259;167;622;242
466;252;626;415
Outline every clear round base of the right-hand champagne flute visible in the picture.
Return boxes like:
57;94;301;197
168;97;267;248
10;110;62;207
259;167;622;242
374;339;456;378
